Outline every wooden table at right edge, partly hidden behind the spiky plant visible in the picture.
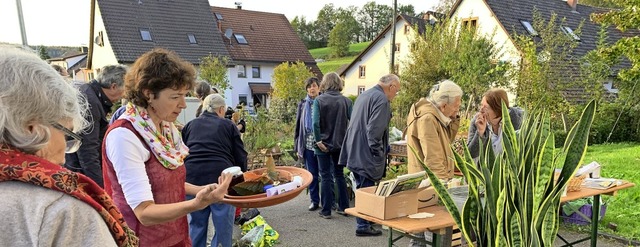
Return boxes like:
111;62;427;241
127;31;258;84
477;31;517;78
558;182;635;247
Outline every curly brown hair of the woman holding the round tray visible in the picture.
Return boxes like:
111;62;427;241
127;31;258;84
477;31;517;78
125;48;196;108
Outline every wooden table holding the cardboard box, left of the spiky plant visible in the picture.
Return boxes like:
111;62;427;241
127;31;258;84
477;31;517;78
345;206;456;247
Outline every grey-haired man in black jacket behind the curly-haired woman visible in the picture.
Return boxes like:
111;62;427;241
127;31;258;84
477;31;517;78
65;65;127;187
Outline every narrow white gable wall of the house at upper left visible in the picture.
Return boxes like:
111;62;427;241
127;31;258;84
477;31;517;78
90;4;118;74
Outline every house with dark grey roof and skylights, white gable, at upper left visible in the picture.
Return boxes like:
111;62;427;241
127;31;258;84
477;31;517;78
86;0;229;79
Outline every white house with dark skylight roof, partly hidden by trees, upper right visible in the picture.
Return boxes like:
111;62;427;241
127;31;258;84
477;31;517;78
449;0;637;101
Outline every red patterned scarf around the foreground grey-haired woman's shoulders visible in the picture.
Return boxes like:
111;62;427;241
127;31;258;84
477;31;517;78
0;145;138;246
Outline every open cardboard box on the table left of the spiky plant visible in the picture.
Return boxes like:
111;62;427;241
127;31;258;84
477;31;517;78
355;186;420;220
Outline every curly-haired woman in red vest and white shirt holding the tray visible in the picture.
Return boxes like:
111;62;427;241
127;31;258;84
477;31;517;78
102;48;231;246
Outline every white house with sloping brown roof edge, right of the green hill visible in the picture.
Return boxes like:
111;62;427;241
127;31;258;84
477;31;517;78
338;12;436;95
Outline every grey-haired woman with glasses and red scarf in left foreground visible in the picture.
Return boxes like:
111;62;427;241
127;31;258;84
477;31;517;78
0;47;138;246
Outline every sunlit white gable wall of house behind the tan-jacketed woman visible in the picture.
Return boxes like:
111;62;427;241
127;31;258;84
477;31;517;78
342;19;415;95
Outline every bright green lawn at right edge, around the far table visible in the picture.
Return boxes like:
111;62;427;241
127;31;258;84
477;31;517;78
584;143;640;240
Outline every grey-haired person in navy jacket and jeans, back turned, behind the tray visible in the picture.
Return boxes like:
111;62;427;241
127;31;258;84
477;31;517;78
182;94;247;247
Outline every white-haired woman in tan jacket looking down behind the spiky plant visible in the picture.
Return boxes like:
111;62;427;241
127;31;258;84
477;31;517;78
407;80;462;179
